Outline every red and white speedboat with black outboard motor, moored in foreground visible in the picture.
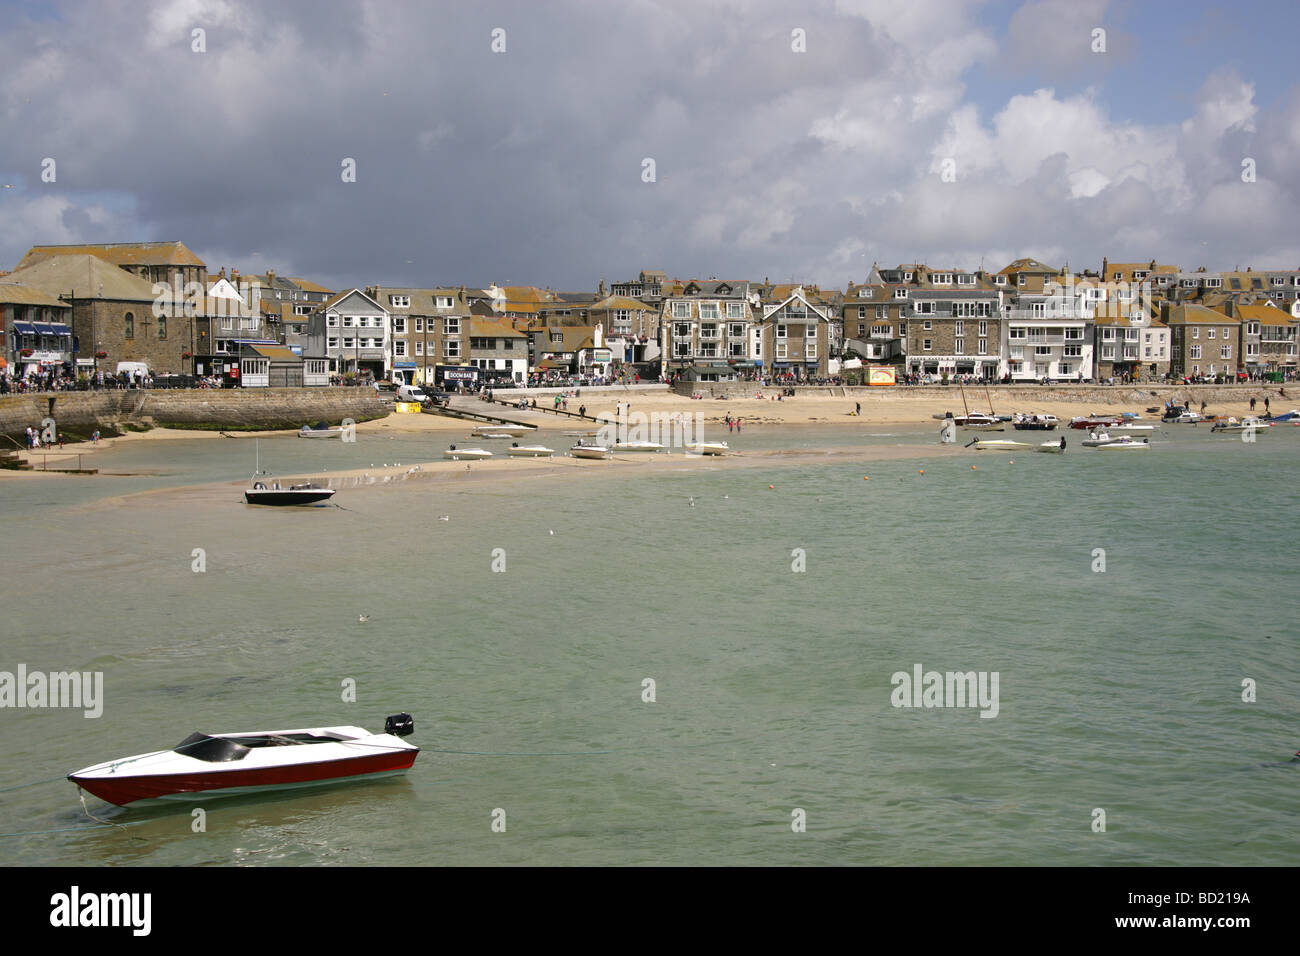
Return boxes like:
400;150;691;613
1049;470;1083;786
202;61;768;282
68;714;420;806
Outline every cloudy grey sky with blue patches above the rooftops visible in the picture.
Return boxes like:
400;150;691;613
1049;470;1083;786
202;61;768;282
0;0;1300;291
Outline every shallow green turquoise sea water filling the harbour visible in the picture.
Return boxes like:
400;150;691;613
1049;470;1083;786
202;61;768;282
0;425;1300;865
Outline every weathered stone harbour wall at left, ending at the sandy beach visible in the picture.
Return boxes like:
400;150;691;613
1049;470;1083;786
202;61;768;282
0;388;391;444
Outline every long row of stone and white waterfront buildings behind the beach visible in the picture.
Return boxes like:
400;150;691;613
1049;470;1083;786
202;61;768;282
0;242;1300;386
